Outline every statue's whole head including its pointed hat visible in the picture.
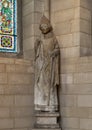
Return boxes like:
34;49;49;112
39;15;52;34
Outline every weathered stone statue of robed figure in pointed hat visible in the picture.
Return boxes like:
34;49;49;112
34;16;60;112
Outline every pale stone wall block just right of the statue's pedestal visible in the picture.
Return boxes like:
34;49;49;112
62;118;79;129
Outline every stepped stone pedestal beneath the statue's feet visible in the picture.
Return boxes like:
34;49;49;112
33;112;60;130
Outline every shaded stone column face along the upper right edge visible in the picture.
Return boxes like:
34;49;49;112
79;0;92;56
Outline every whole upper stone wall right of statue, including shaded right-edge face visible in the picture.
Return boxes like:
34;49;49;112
52;0;92;58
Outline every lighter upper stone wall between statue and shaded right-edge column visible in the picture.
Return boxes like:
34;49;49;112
51;0;80;58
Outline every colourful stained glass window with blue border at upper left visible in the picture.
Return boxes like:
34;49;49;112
0;0;17;52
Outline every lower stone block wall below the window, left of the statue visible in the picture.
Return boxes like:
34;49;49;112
0;58;34;130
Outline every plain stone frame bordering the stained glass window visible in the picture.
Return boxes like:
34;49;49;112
0;0;23;57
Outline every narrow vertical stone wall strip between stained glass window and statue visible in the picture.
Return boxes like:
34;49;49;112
22;0;34;59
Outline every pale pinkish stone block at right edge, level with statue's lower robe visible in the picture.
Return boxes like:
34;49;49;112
78;95;92;107
